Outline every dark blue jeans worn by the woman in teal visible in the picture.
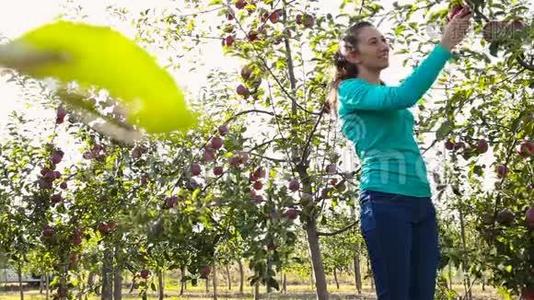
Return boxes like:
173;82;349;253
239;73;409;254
360;190;440;300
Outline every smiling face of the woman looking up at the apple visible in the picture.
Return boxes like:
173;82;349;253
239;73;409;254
348;26;389;71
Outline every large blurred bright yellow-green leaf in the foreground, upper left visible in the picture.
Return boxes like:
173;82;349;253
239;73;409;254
0;21;196;133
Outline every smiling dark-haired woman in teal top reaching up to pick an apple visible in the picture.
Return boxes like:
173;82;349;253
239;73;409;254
329;8;471;300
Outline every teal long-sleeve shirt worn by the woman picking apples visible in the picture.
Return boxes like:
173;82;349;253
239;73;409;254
338;43;452;197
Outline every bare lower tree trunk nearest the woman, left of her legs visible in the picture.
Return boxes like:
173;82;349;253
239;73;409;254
306;219;328;300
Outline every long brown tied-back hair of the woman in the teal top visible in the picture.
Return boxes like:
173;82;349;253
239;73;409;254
325;21;373;115
